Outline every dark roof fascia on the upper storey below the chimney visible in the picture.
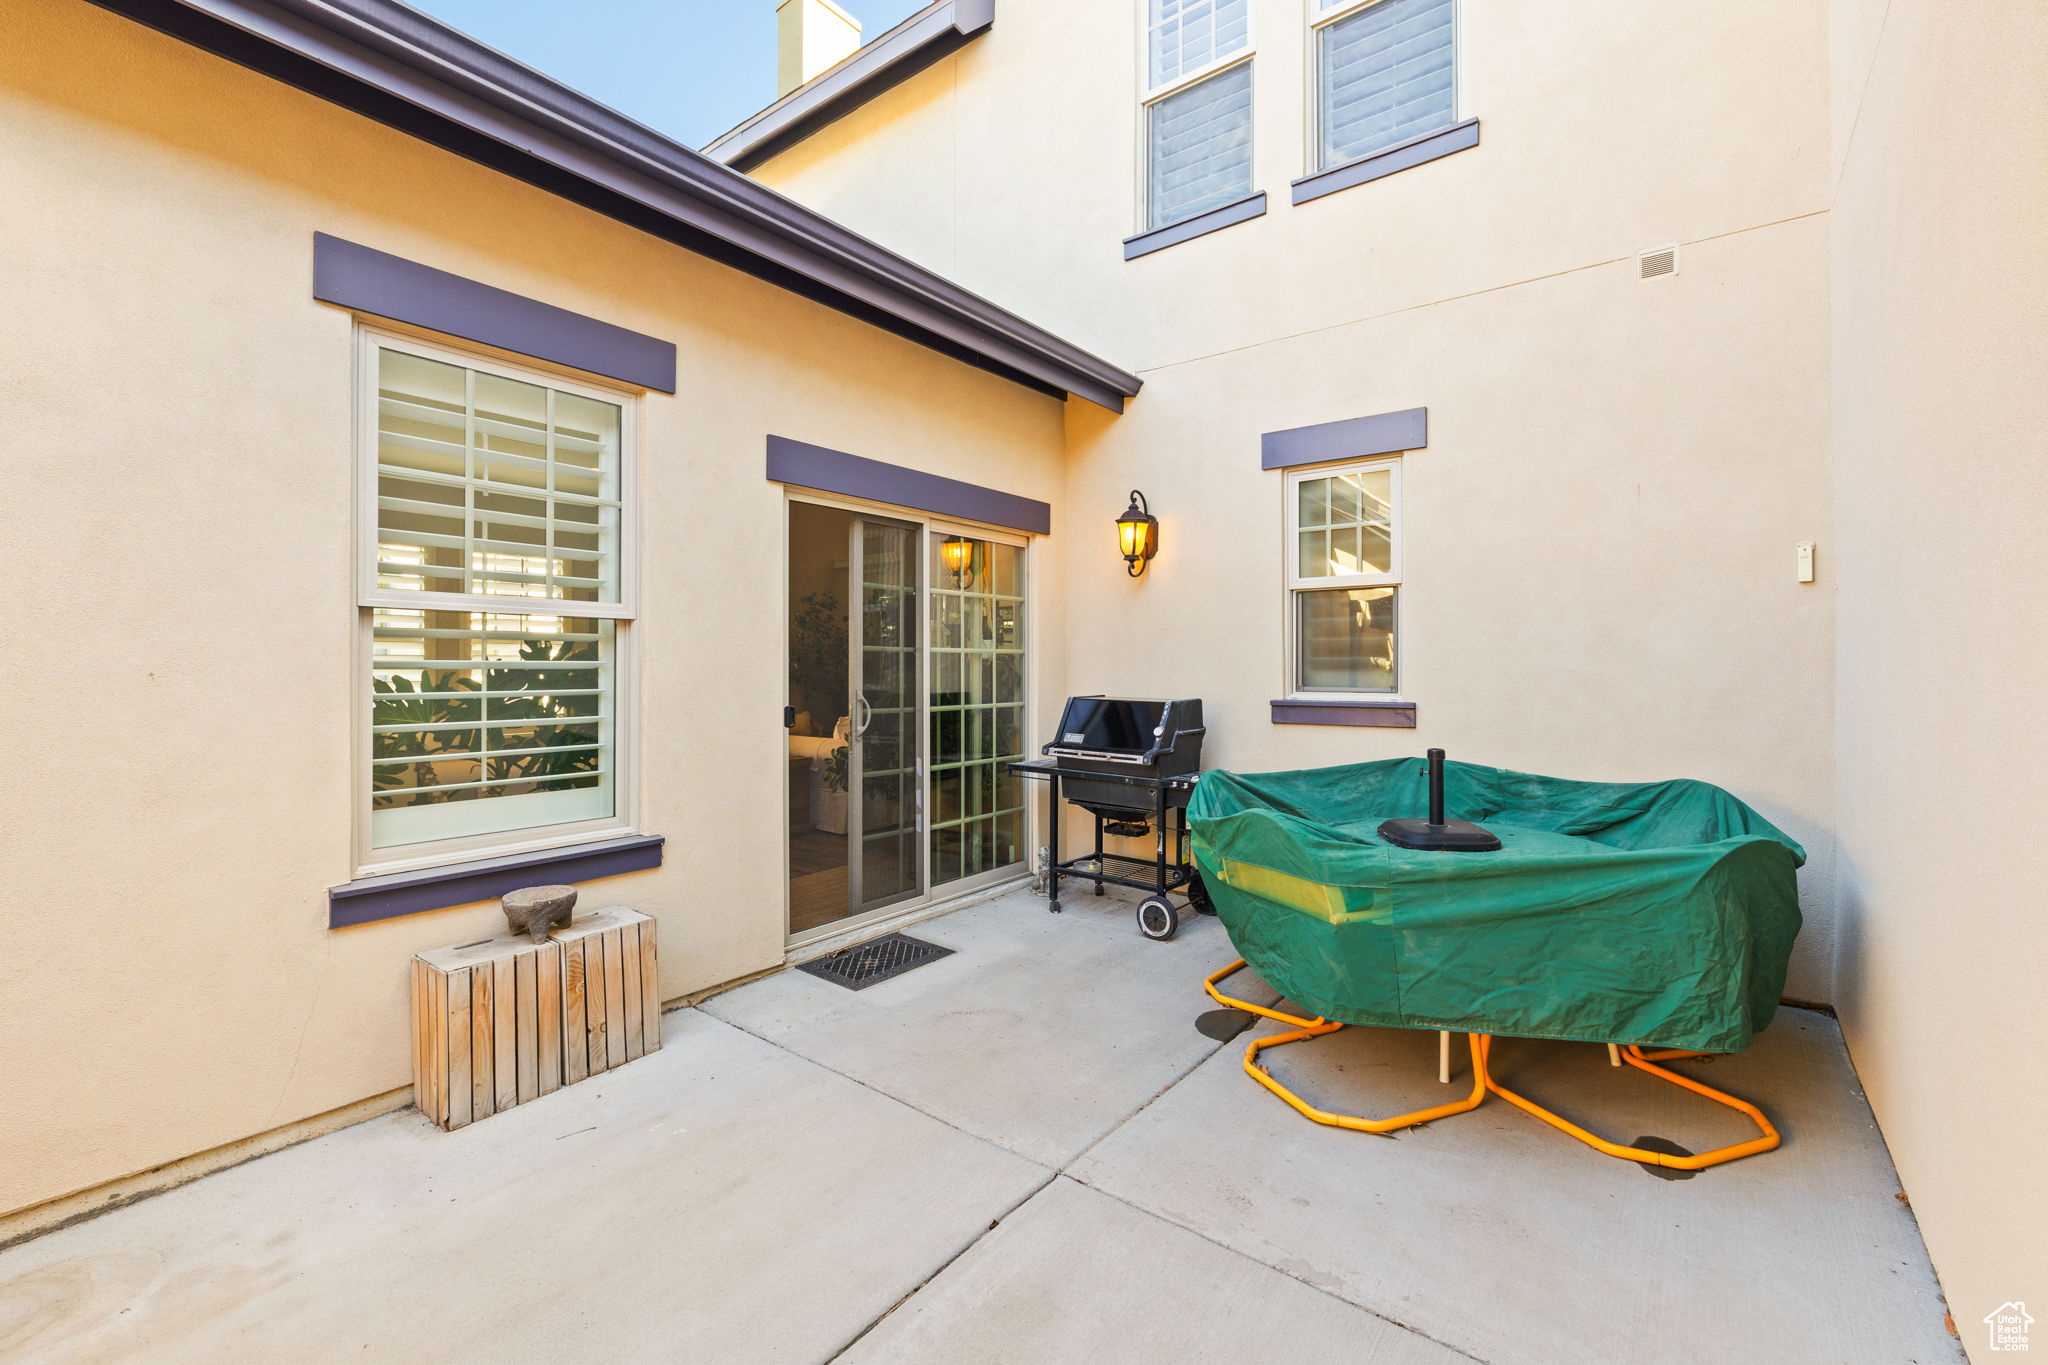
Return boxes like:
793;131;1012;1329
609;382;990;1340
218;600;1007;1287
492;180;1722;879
705;0;995;170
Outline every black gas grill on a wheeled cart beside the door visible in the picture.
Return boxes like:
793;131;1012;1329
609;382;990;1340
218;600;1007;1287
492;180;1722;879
1010;696;1214;939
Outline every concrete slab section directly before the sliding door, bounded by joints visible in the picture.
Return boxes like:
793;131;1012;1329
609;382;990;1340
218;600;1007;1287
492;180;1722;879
702;888;1274;1166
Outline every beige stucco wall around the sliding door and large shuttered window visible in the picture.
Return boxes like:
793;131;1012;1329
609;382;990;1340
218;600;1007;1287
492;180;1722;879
0;0;1063;1212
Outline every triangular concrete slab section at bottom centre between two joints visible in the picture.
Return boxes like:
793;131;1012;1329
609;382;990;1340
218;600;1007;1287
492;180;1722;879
840;1179;1468;1365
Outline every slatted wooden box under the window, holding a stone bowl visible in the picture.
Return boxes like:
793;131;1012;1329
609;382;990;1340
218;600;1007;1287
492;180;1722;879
399;909;662;1128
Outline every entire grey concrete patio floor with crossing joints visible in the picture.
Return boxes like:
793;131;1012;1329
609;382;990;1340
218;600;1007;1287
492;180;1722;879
0;894;1960;1365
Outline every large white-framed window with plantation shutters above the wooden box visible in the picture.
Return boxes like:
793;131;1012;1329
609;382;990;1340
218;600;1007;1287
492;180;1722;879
356;325;639;870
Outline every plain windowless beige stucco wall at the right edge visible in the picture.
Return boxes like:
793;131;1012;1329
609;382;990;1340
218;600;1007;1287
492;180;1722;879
1833;0;2048;1361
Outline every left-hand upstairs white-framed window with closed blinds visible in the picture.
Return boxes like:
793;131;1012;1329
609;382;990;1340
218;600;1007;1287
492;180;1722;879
1141;0;1251;229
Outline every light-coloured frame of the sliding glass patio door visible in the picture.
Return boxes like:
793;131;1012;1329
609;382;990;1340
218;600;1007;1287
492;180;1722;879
776;485;1042;950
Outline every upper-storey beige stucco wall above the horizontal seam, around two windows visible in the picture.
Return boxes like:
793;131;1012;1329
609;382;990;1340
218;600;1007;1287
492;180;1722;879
754;0;1829;368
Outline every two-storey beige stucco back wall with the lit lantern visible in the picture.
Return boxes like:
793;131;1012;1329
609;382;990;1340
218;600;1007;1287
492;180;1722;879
756;0;1835;1001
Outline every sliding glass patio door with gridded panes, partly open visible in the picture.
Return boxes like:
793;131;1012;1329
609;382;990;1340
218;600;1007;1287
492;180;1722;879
784;499;1026;939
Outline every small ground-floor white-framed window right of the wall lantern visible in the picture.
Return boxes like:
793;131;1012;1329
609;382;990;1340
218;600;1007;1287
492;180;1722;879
1286;458;1401;696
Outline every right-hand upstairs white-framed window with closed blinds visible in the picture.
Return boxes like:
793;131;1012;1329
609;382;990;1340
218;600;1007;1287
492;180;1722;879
1309;0;1458;170
